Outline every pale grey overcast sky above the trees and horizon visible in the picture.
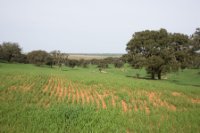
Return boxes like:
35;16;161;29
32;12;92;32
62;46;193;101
0;0;200;53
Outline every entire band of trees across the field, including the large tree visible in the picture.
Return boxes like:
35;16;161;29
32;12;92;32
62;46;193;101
0;28;200;79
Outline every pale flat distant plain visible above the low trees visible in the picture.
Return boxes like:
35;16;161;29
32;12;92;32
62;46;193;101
69;54;122;60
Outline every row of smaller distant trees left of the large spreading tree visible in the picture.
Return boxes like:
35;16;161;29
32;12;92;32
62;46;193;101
0;42;124;71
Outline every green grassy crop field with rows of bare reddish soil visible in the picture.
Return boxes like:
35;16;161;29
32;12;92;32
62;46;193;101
0;63;200;133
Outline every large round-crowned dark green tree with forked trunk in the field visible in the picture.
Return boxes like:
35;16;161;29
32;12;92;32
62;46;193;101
125;29;189;79
